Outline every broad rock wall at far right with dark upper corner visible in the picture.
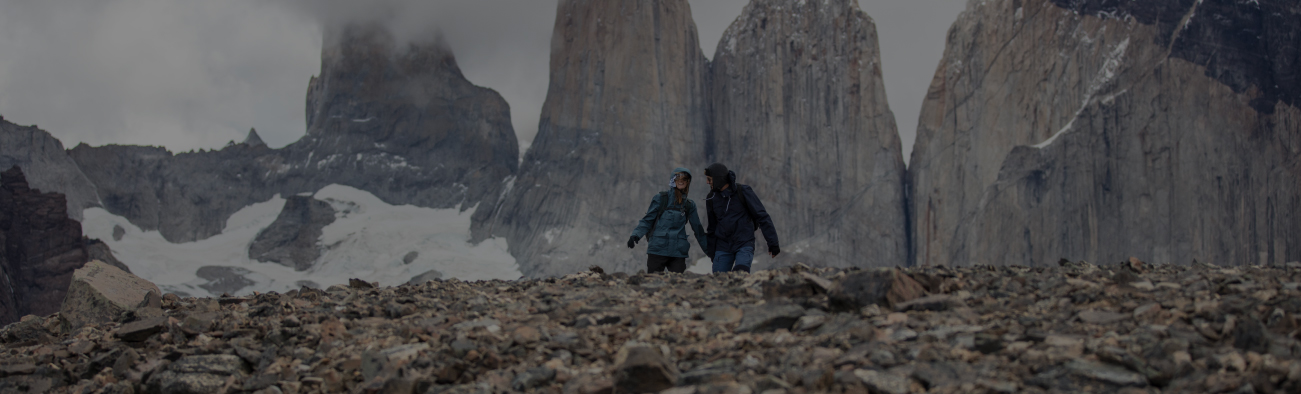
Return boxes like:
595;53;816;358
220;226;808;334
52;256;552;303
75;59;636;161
909;0;1301;265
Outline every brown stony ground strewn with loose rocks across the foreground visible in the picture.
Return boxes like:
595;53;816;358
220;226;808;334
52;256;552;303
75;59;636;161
0;259;1301;393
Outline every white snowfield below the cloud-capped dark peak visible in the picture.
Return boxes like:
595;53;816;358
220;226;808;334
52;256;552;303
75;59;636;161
82;185;522;296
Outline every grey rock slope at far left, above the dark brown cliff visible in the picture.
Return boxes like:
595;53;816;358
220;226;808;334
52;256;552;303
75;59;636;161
0;117;99;220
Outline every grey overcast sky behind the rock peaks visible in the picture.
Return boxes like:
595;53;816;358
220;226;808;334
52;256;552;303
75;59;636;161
0;0;965;163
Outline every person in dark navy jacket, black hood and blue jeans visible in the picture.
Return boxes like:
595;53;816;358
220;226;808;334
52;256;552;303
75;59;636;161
705;163;782;272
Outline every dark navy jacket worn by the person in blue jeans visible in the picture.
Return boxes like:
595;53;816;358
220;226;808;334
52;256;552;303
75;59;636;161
705;172;779;257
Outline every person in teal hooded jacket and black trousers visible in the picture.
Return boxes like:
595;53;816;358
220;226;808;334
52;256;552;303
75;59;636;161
628;166;708;273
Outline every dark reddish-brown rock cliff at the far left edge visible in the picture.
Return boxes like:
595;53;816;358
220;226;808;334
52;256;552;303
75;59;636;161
0;166;126;325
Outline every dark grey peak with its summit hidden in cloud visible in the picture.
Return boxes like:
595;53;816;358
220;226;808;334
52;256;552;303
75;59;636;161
292;21;519;217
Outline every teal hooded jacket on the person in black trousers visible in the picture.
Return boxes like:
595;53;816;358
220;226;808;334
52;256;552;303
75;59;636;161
632;166;709;257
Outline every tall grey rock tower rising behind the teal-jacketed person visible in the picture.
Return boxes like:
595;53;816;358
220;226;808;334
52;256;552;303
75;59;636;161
475;0;709;277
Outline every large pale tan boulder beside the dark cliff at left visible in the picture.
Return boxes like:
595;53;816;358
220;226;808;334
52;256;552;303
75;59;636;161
60;260;163;329
